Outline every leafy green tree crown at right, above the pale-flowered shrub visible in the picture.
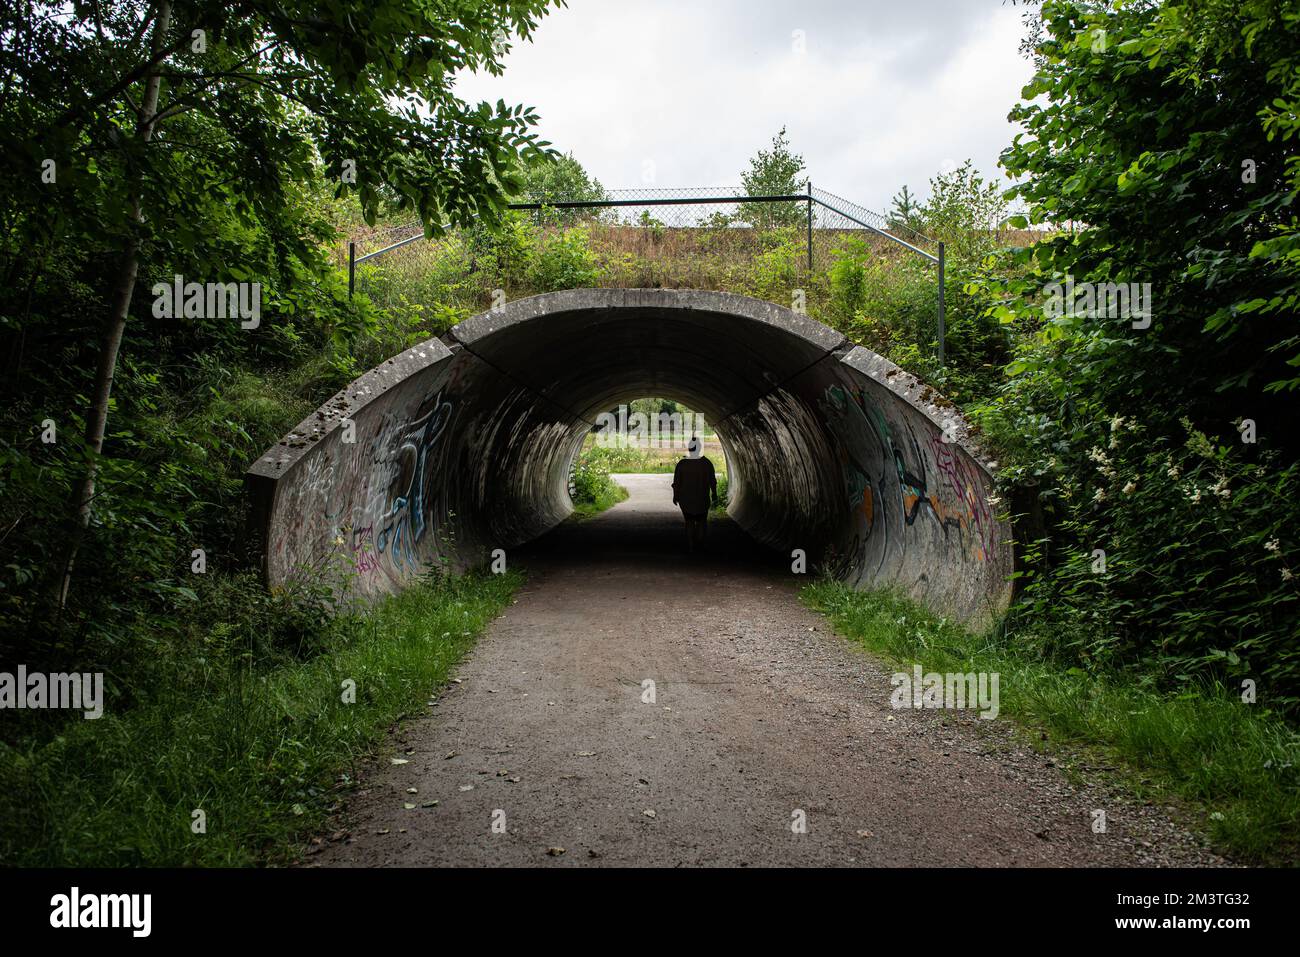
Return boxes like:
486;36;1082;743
1002;0;1300;423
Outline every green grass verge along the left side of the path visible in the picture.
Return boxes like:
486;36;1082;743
0;572;521;867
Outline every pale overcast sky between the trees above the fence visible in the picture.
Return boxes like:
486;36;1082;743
456;0;1032;211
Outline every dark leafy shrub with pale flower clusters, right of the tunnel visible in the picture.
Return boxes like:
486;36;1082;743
1017;416;1300;711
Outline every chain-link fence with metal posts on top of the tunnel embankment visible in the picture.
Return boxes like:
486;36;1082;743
345;183;944;361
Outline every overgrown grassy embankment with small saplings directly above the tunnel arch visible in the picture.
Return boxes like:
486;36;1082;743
358;143;1023;402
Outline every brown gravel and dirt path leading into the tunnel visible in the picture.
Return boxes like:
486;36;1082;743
307;476;1222;866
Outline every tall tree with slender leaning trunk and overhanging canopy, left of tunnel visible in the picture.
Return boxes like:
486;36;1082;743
0;0;563;606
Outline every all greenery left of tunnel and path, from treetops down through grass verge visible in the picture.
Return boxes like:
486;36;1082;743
0;0;554;865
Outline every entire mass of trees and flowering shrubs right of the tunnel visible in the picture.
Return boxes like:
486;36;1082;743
967;0;1300;714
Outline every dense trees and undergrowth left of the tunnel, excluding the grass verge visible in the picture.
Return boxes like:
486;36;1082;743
0;0;564;687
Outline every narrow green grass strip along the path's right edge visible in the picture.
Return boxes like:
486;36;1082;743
801;581;1300;866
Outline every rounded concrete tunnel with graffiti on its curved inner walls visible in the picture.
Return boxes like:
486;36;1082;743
247;289;1013;627
